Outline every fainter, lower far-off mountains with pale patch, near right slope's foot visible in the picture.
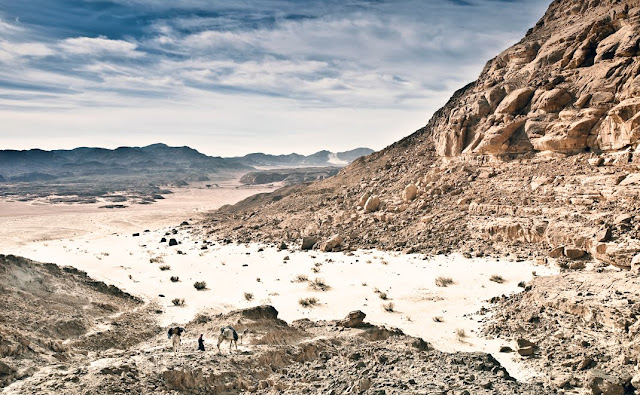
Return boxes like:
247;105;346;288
231;148;374;167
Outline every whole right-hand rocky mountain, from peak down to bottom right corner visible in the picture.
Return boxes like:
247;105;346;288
204;0;640;394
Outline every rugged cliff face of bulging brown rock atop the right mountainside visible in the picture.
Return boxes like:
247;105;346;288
425;0;640;157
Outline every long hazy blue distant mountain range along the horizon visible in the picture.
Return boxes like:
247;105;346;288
0;144;373;182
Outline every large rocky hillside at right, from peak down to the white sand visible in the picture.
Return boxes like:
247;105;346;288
205;0;640;267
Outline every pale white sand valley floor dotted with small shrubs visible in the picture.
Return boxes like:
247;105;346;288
0;182;555;380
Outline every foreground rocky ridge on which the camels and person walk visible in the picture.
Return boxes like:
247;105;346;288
7;306;551;394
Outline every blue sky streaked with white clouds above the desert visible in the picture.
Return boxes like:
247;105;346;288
0;0;549;156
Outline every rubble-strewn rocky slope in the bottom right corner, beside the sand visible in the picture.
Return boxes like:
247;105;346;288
485;271;640;394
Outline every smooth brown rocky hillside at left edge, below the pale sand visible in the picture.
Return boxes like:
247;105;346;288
0;255;159;388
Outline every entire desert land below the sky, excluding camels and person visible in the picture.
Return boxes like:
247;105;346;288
0;0;640;395
